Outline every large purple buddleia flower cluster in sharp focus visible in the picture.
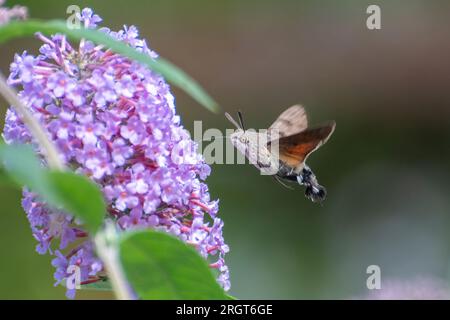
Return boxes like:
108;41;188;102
3;9;230;297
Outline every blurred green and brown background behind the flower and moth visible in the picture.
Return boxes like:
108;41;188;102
0;0;450;299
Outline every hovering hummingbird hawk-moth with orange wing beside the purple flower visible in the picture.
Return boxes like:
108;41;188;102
225;105;336;202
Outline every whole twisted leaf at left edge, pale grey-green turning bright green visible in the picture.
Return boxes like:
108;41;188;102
0;144;105;233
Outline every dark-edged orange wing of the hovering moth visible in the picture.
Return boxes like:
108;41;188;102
269;121;336;168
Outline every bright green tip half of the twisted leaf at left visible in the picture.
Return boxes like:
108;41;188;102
47;171;105;233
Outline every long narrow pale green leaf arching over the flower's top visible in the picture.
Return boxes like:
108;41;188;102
0;19;220;113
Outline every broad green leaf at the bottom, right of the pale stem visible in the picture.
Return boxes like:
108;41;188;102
120;230;227;300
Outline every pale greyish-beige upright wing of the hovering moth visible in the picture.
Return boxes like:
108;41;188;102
268;105;308;141
